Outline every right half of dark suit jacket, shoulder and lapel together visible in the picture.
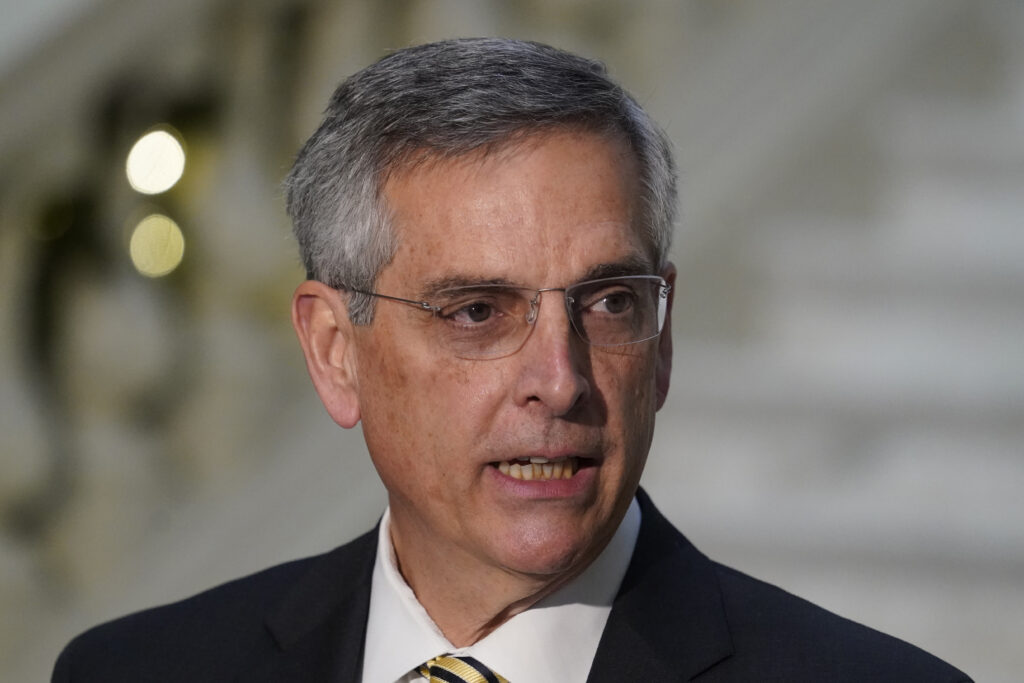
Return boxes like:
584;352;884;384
622;490;970;683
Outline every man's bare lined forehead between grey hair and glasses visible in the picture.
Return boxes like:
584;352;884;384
381;131;653;287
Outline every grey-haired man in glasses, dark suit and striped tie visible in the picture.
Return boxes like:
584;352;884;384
54;39;968;683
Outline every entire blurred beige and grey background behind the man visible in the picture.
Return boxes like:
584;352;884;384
0;0;1024;682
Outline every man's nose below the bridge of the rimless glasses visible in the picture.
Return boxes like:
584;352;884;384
514;291;591;417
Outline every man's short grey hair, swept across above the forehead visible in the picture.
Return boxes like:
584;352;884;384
285;38;676;325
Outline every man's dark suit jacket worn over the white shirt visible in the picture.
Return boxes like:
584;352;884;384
53;492;970;683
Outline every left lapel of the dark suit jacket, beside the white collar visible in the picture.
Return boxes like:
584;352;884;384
238;528;377;683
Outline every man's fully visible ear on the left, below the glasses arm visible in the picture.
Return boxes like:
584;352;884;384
292;280;359;429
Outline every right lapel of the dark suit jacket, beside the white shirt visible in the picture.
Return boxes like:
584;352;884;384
587;489;732;683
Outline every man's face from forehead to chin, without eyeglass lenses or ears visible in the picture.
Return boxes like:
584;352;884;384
353;132;672;586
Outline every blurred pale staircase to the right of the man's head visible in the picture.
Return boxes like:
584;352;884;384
646;2;1024;680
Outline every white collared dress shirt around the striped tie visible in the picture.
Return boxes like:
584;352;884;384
362;499;640;683
